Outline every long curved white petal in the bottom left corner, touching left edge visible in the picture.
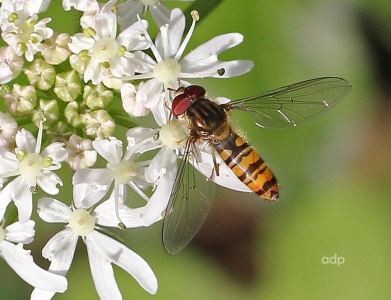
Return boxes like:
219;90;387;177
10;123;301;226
1;241;68;293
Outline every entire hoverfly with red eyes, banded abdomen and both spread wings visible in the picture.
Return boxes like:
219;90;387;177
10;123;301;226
163;77;351;254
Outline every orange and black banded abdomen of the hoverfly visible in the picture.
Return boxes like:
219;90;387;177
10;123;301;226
211;129;279;200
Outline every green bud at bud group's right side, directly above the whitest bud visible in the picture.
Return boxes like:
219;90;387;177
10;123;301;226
83;84;114;110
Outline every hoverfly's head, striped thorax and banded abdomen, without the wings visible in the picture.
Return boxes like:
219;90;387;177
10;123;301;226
173;85;279;200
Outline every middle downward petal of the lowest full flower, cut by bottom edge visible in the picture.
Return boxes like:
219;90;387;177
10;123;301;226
86;231;122;300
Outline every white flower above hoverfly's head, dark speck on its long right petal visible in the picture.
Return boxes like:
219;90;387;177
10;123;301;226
125;9;254;122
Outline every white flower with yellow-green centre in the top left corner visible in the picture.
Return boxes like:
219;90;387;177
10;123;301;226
0;0;53;61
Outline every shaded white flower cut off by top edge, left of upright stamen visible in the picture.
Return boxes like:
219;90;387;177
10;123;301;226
118;0;193;27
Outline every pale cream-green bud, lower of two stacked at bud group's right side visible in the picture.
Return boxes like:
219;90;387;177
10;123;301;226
84;109;115;139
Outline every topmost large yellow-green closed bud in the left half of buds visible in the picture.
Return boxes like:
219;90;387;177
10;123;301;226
24;58;56;91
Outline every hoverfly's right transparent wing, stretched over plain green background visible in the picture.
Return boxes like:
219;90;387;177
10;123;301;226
224;77;351;128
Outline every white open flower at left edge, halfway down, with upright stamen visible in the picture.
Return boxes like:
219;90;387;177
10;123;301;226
0;122;68;223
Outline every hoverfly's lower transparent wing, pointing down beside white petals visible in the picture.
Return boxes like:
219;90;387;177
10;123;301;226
163;138;214;255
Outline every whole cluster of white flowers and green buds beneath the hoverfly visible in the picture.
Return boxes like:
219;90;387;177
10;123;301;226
0;0;253;299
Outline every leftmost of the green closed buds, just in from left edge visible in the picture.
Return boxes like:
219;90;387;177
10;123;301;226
4;84;37;116
